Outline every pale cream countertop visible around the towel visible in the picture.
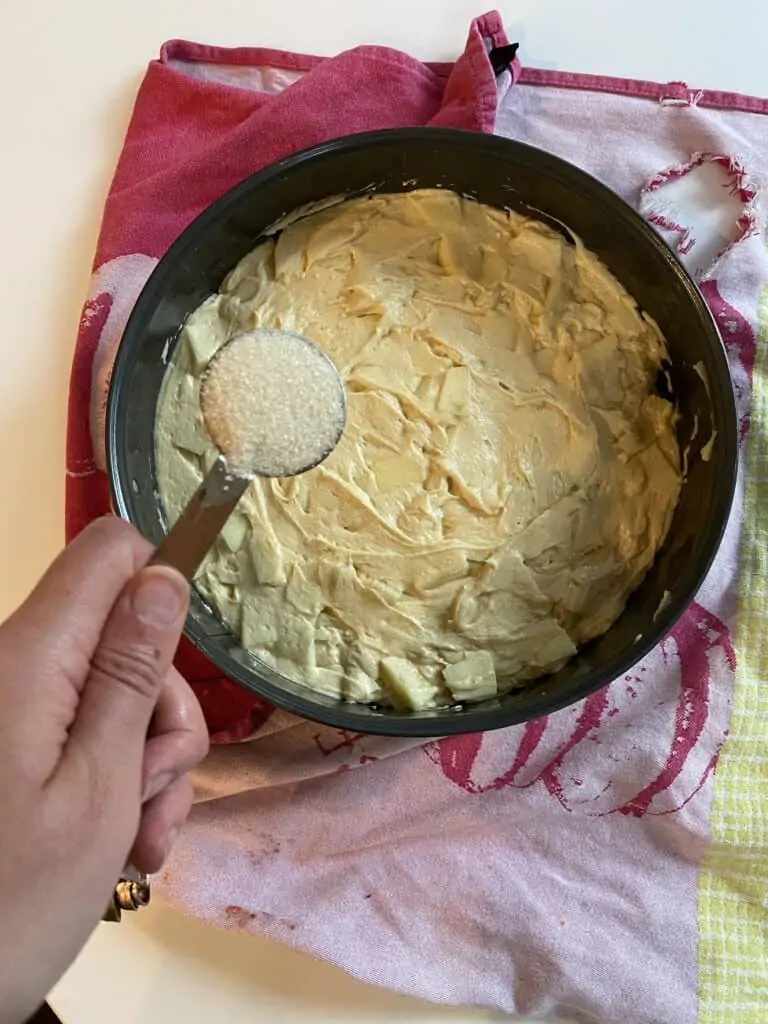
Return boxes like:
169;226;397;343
0;0;768;1024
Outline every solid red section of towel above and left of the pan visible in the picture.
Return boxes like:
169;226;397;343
67;13;507;742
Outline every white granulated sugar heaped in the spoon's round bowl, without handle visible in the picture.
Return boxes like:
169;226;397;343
201;329;346;476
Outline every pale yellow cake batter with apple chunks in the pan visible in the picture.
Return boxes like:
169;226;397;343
157;190;681;708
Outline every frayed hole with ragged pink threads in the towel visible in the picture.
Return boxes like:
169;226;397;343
639;153;758;280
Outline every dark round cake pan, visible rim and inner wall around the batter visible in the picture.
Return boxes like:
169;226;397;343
106;128;737;736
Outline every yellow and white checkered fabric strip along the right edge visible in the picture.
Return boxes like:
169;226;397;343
698;289;768;1024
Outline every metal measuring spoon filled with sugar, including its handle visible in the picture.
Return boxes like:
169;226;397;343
151;328;347;580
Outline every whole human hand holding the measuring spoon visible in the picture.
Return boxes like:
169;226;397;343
0;519;208;1024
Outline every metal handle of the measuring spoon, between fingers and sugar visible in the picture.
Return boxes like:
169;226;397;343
150;458;251;581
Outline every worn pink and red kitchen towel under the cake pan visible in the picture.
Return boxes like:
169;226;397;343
68;14;768;1024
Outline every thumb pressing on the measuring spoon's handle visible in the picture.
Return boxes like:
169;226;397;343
65;565;189;787
